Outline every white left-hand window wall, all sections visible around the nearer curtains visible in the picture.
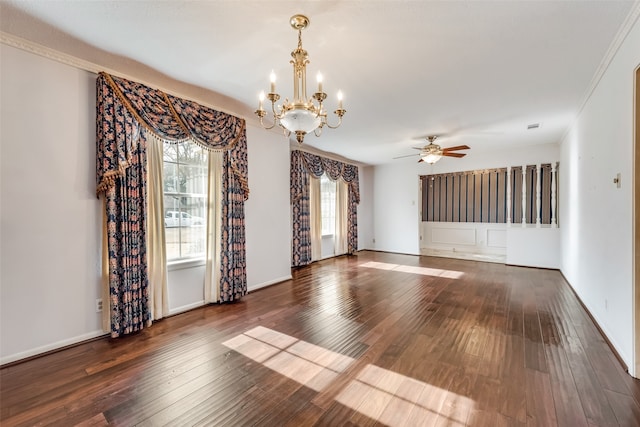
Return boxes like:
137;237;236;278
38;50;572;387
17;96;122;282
0;44;291;364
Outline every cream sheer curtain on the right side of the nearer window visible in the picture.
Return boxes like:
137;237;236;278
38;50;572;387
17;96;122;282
204;151;224;303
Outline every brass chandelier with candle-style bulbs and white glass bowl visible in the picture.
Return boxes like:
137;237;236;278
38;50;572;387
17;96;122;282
256;15;347;144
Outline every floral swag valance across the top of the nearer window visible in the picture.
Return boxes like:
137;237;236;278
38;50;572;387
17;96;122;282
96;72;249;200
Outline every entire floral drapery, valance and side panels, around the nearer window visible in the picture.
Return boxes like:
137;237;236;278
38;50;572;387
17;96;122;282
96;73;249;336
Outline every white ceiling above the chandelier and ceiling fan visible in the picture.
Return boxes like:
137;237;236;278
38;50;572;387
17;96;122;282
0;0;638;164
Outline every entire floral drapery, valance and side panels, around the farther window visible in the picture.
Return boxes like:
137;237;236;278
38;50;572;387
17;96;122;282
291;150;360;267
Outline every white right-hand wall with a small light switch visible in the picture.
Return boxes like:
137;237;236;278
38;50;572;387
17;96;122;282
559;15;640;369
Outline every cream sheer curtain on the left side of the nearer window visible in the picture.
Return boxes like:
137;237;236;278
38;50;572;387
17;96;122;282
147;132;169;320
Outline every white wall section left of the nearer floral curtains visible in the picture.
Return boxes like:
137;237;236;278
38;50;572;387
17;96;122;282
0;44;102;362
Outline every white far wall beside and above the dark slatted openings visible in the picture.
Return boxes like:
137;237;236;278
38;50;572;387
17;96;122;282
368;144;559;254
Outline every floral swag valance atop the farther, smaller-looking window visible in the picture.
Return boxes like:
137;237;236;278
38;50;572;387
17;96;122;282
291;150;360;204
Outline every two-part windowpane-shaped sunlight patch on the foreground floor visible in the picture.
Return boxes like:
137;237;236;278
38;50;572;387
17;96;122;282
222;326;475;427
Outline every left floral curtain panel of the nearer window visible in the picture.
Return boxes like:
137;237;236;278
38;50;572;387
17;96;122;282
96;76;151;337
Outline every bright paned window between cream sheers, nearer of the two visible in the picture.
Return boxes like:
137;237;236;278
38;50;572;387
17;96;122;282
163;141;207;261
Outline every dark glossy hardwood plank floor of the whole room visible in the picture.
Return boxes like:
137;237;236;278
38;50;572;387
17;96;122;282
0;252;640;427
